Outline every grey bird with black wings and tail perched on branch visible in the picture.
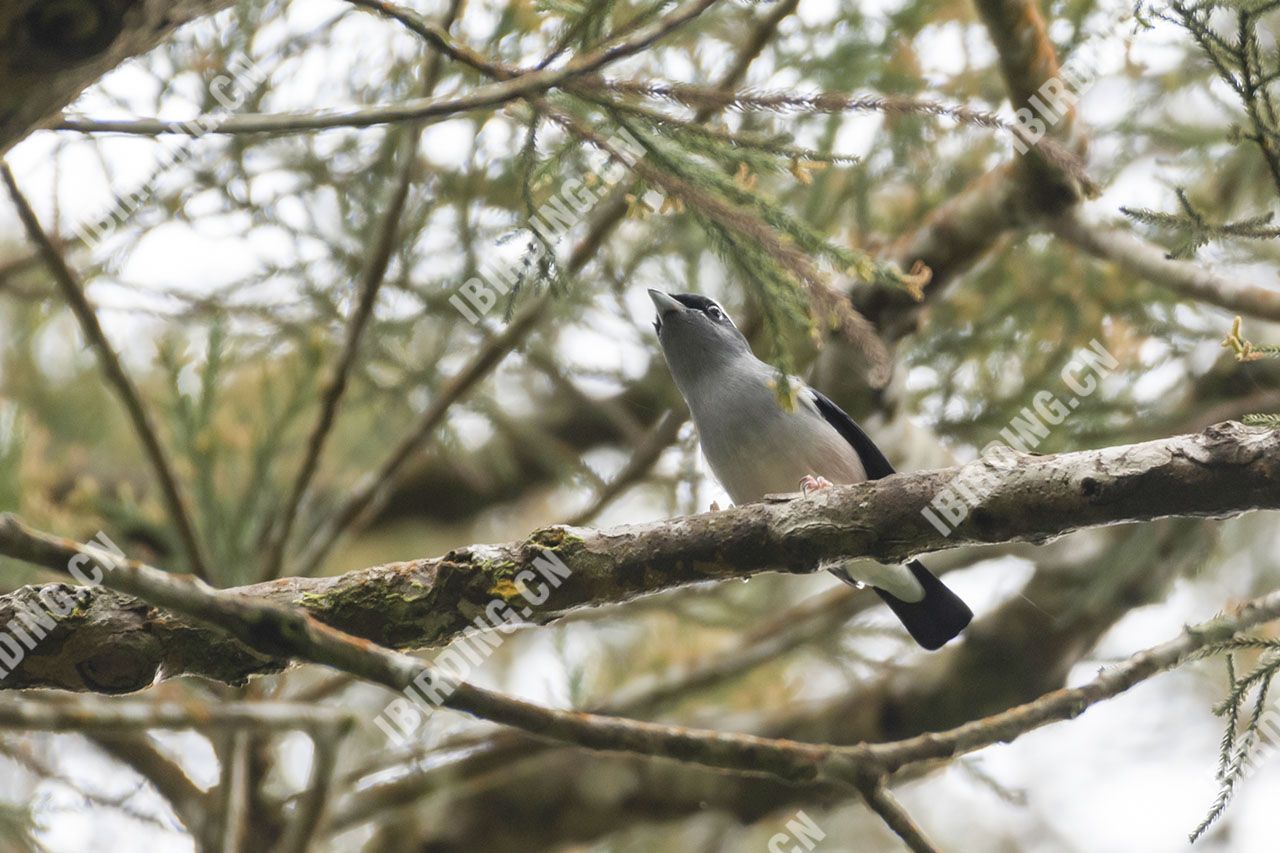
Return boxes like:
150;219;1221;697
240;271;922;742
649;289;973;651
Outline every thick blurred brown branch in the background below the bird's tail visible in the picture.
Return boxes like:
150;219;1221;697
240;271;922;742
381;519;1249;853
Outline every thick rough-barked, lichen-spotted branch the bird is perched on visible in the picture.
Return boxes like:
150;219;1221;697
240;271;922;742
0;423;1280;693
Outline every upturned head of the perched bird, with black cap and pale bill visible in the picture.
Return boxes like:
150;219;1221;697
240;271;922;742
649;289;753;388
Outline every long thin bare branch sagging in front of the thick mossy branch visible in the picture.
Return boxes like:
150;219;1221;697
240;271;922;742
0;504;1280;849
